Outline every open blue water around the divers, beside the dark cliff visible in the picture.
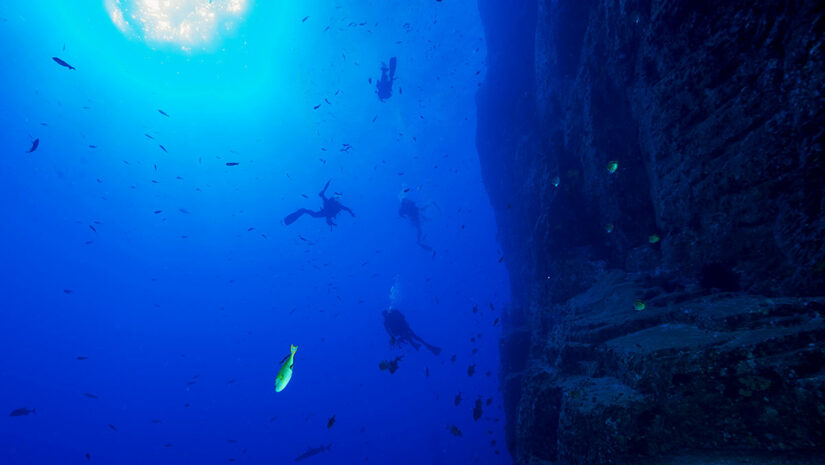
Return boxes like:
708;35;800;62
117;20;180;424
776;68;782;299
0;0;510;465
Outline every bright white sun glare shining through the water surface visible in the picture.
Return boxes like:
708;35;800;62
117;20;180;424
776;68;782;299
105;0;250;50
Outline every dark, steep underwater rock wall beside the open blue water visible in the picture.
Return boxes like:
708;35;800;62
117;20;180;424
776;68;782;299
478;0;825;464
